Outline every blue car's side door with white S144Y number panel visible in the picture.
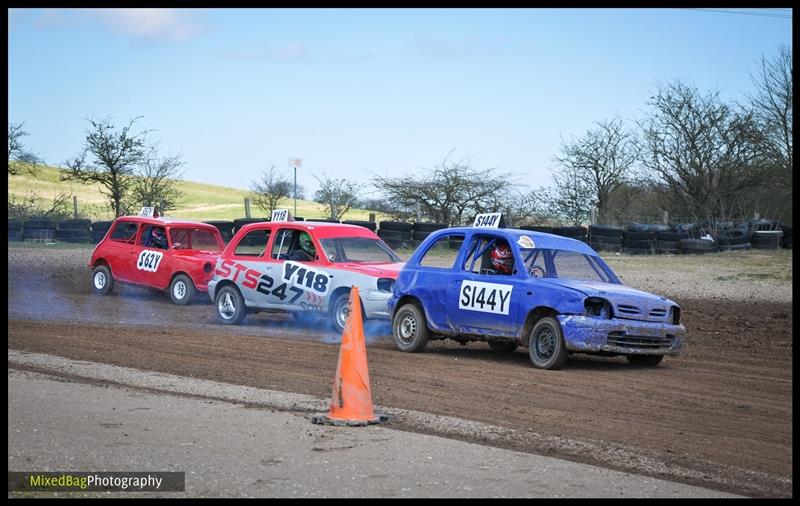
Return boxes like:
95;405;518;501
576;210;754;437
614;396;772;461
448;232;527;335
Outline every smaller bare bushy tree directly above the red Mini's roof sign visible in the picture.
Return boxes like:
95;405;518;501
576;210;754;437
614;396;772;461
131;148;183;214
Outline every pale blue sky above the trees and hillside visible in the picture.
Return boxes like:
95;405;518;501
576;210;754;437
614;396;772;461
8;8;792;198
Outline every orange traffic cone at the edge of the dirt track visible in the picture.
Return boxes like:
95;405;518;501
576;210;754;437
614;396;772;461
311;286;388;425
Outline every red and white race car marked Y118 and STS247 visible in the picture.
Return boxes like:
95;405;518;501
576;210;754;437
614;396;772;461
208;213;403;332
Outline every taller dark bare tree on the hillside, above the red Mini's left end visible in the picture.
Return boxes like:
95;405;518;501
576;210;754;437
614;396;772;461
61;118;147;217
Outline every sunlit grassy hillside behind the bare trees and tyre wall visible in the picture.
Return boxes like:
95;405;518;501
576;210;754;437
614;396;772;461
8;166;388;221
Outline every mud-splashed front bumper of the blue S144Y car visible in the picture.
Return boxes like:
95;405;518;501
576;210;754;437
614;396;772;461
557;315;686;355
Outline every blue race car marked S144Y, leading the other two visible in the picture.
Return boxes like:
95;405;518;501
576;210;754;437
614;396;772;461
389;215;686;369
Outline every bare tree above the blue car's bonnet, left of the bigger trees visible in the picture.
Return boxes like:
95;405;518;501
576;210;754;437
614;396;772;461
555;117;639;222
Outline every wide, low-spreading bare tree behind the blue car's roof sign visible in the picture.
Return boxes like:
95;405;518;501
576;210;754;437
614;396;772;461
376;151;515;225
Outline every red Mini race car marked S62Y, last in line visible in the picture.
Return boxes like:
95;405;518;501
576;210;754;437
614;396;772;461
89;216;225;305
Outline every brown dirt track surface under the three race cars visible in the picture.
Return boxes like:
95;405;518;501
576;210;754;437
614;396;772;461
8;247;792;497
